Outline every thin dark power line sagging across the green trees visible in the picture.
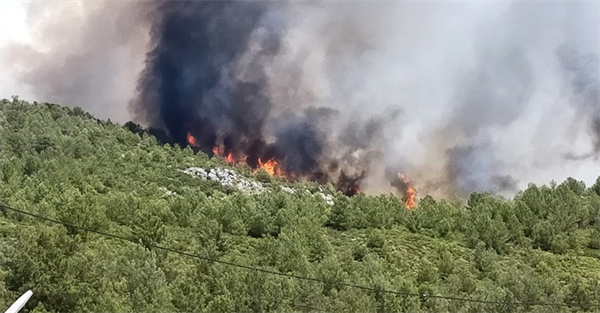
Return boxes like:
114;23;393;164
0;203;600;312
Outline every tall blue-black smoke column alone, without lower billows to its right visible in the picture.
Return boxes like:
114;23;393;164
136;0;279;152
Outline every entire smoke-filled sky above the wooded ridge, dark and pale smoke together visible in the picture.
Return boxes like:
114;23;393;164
0;0;600;195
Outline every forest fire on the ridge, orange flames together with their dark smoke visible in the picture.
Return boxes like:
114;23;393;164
144;1;415;207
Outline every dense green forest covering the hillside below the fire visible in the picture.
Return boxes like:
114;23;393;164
0;97;600;313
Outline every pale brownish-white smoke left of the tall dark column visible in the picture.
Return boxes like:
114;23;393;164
2;1;148;122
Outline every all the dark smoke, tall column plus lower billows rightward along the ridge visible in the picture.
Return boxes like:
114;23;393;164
132;0;384;188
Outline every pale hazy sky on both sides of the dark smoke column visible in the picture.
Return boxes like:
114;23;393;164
0;0;600;190
